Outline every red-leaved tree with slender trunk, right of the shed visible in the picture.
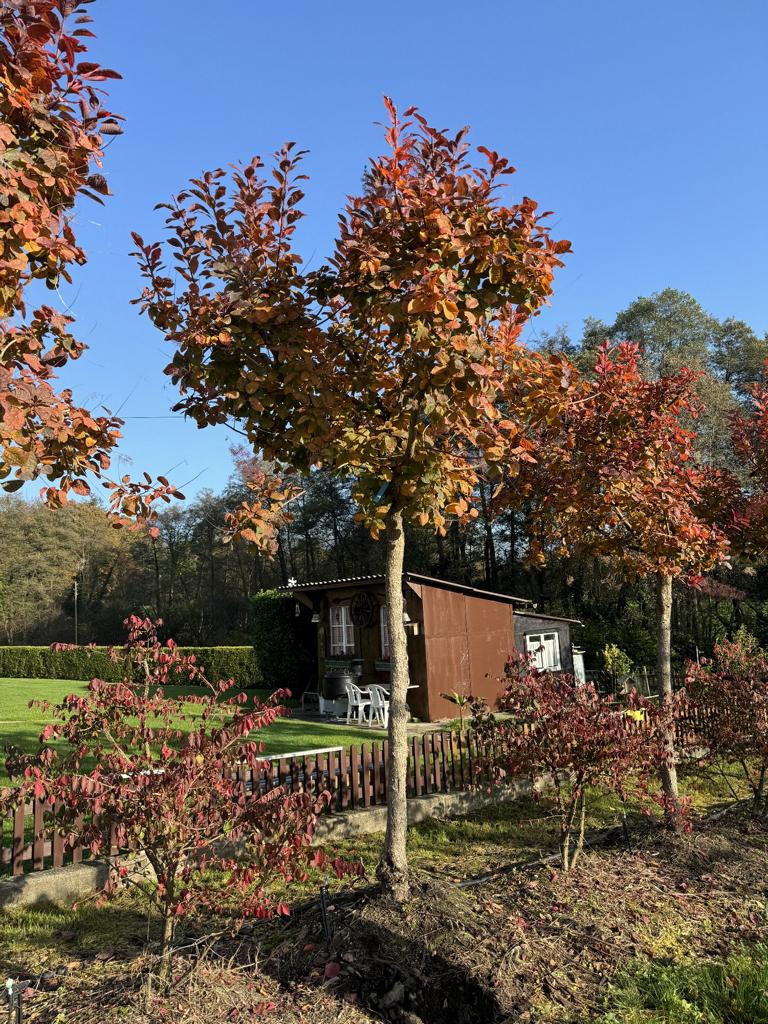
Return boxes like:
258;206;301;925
510;342;728;809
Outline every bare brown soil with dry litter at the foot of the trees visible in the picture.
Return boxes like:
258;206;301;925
7;812;768;1024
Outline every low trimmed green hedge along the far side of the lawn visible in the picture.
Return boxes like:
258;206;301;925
0;647;261;687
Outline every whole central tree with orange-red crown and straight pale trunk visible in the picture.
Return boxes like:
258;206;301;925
136;100;569;896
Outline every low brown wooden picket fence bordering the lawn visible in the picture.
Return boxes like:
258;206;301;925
0;731;480;874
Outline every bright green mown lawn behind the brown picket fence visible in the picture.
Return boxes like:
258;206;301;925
0;679;385;780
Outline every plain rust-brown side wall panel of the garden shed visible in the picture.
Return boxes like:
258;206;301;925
422;586;514;721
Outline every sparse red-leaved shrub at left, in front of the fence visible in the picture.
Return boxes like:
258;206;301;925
0;615;357;979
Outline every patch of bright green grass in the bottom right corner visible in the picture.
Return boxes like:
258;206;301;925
598;943;768;1024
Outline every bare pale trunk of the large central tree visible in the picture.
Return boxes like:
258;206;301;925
378;508;409;902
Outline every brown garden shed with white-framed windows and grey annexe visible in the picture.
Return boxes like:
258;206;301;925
282;572;575;722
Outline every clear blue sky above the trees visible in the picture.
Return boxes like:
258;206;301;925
52;0;768;496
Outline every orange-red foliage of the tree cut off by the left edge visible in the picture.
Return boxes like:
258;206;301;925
0;0;177;524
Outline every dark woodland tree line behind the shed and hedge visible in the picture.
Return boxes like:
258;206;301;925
6;289;768;668
